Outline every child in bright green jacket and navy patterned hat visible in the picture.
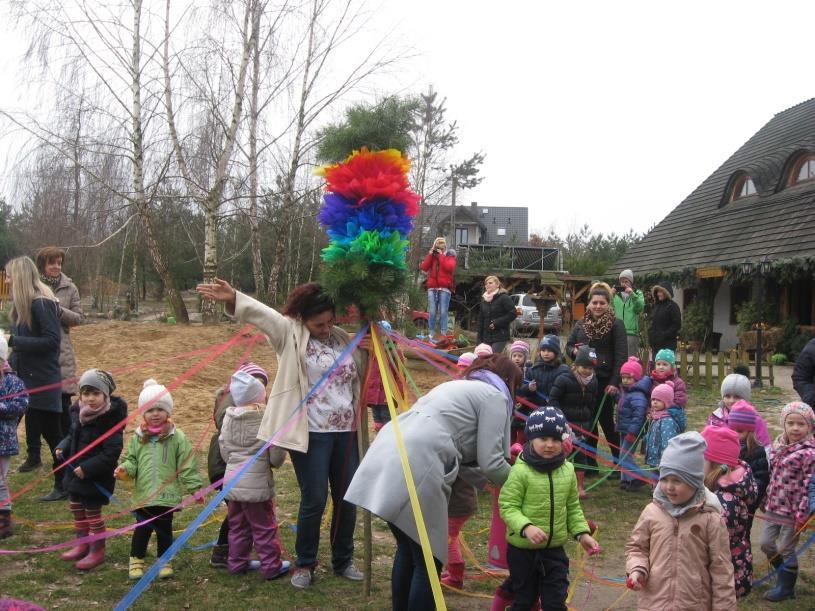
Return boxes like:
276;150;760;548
498;407;600;610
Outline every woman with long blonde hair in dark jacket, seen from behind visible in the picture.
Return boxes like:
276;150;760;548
6;257;67;501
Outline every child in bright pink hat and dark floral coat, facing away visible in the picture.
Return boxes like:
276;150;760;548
702;426;758;598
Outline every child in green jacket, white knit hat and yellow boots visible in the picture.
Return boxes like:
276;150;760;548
114;379;204;579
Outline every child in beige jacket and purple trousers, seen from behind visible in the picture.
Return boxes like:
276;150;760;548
219;371;289;579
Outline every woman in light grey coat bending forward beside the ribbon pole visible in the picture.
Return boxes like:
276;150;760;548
345;354;523;611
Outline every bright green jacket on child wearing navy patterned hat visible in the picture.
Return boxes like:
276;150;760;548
498;456;589;549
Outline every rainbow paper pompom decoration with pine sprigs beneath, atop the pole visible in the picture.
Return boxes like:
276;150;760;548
317;147;420;315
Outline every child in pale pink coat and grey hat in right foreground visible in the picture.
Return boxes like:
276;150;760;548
625;432;736;611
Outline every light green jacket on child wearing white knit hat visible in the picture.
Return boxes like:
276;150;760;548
121;426;204;507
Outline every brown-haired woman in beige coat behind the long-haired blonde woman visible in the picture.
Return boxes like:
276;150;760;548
35;246;85;444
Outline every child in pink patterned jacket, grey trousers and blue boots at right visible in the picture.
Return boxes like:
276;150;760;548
760;401;815;602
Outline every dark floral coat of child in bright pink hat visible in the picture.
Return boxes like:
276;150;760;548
716;461;758;598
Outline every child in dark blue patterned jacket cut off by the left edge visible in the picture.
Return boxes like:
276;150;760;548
0;333;28;539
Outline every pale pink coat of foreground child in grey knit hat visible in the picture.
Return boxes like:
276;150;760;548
625;500;736;611
